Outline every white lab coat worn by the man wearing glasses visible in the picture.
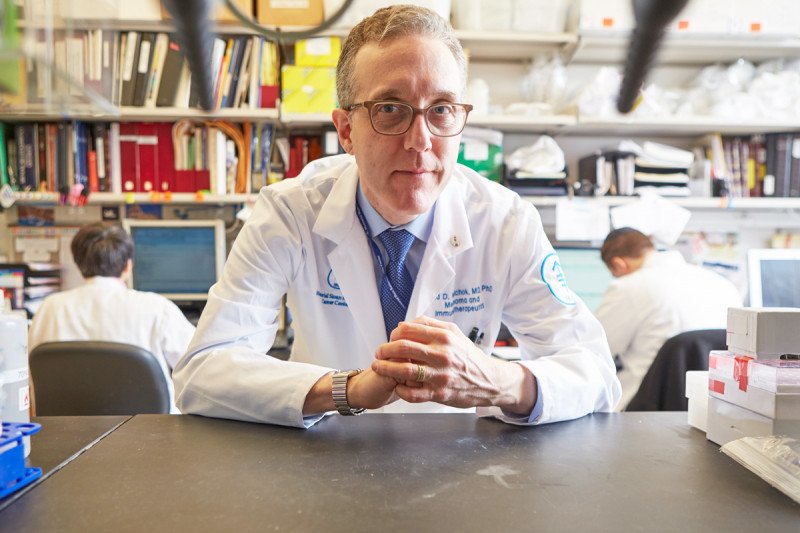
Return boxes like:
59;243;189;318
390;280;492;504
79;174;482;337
173;155;619;427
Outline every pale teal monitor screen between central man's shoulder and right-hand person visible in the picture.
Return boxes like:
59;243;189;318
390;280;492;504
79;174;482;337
556;247;613;313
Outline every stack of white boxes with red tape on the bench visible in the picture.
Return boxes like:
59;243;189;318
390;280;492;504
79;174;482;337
706;308;800;445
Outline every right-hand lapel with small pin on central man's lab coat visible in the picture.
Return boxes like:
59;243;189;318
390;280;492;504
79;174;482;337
406;170;473;320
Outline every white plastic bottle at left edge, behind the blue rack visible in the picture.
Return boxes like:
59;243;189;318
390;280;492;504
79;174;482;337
0;311;31;457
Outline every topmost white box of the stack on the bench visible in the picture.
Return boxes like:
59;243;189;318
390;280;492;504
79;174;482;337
727;307;800;359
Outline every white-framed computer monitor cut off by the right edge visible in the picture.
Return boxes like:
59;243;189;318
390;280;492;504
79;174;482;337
747;248;800;307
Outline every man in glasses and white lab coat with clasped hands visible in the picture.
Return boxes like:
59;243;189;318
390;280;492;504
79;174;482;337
174;6;619;427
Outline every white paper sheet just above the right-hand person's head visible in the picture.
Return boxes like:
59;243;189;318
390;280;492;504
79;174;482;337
611;193;692;246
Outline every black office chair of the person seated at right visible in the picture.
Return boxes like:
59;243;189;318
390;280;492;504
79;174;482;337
625;329;727;411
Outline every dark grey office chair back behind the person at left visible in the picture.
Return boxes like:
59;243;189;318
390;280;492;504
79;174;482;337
30;341;170;416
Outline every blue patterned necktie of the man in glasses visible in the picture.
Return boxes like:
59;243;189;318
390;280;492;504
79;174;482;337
378;229;414;339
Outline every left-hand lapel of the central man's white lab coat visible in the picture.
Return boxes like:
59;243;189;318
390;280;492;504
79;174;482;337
314;164;386;347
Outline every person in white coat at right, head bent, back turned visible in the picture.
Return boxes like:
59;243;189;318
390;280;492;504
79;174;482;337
595;228;742;409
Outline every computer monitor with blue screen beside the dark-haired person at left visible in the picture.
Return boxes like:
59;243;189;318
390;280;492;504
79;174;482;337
123;219;225;301
